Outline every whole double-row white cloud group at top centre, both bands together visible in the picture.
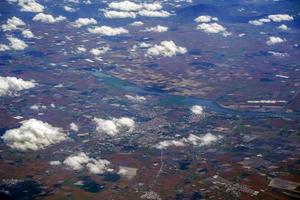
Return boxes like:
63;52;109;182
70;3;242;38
104;0;171;18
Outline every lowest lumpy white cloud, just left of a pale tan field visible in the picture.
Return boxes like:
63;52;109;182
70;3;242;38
63;152;113;174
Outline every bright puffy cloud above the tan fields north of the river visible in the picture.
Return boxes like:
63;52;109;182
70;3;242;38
146;40;187;57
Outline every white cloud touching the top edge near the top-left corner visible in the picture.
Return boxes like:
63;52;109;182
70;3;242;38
7;0;45;13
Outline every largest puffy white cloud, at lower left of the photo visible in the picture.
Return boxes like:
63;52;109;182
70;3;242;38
1;119;67;151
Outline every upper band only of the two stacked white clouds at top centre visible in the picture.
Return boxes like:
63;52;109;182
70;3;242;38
108;1;162;11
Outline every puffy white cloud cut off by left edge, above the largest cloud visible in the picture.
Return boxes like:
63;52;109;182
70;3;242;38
0;76;37;96
